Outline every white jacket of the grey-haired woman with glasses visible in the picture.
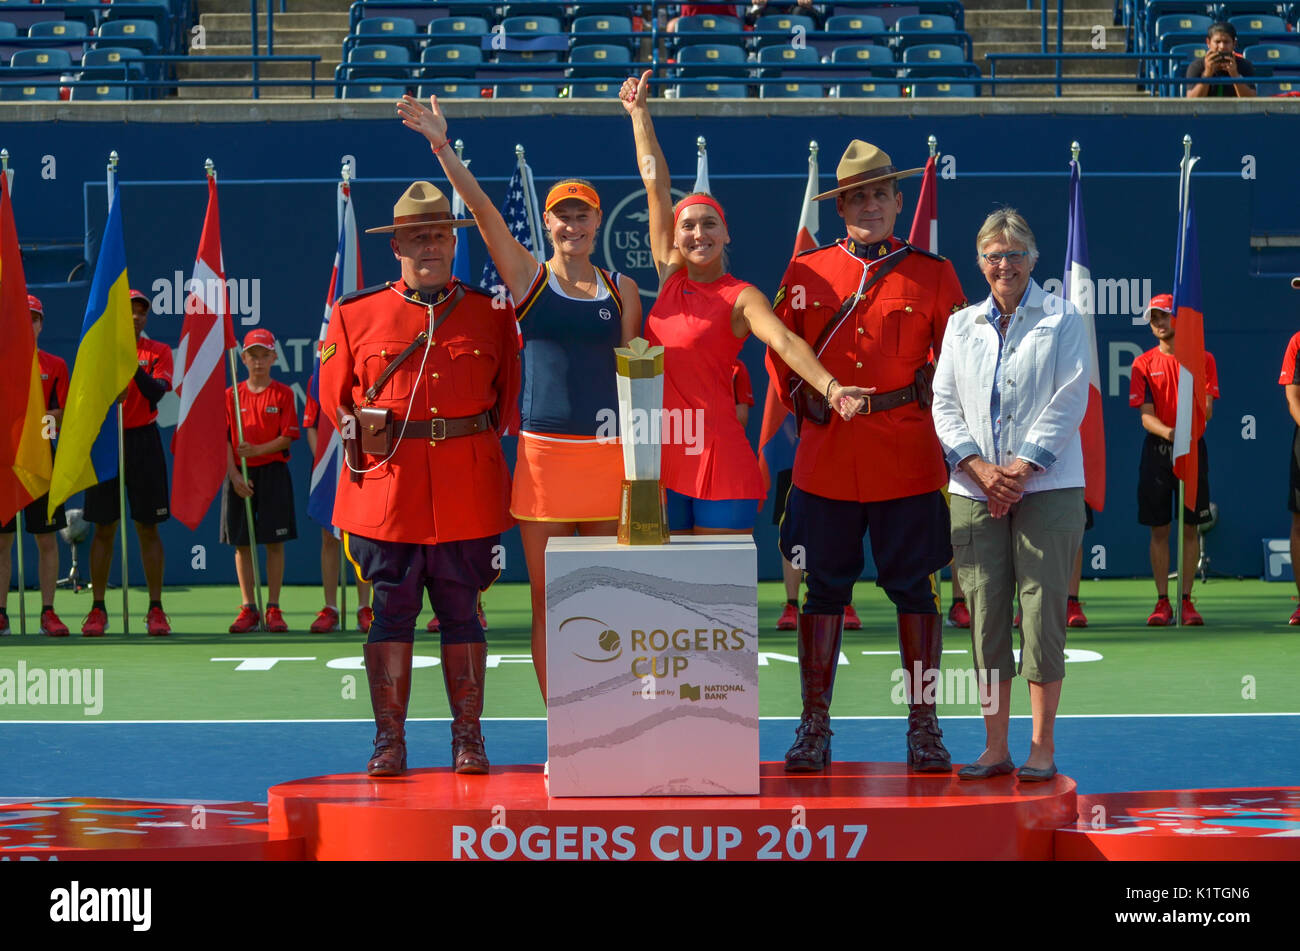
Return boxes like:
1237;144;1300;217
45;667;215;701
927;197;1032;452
932;279;1092;500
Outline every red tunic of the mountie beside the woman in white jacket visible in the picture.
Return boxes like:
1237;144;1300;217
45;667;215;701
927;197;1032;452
767;238;966;501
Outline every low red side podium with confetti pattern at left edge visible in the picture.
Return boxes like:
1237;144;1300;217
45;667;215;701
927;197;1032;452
0;796;303;861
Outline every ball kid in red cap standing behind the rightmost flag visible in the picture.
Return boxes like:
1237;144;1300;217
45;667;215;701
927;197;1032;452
1128;294;1219;628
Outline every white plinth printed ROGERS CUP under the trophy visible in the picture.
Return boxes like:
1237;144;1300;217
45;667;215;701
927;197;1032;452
546;535;758;796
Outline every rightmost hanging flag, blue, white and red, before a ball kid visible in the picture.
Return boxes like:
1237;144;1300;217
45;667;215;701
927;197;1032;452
1173;142;1205;498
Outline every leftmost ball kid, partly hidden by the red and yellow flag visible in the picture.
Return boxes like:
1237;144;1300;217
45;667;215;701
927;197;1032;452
0;294;68;638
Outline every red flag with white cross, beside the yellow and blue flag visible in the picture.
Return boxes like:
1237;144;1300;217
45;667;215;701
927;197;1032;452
172;175;235;530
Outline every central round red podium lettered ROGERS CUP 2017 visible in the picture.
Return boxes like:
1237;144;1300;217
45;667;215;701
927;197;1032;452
268;763;1076;861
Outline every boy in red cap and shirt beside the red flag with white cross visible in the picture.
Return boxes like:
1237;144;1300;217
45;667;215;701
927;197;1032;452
221;327;298;634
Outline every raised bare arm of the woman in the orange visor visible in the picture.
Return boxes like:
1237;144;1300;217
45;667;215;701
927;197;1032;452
398;94;537;300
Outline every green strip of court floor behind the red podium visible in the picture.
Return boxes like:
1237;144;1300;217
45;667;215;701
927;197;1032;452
0;581;1300;721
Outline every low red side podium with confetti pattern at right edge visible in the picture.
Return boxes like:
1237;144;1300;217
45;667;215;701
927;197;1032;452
1056;786;1300;861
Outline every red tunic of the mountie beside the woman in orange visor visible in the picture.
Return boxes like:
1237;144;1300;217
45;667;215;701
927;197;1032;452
320;281;519;544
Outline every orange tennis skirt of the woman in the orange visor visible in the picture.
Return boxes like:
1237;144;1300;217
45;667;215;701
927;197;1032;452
510;433;623;522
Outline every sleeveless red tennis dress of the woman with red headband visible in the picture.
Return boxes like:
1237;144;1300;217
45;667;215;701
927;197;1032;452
646;268;763;500
